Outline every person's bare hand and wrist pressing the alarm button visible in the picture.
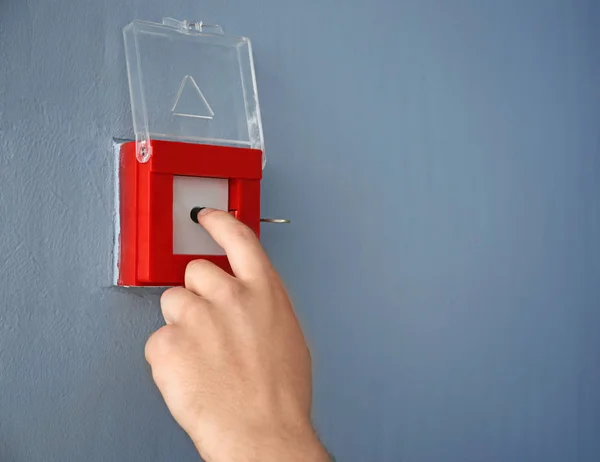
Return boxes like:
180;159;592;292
146;209;329;462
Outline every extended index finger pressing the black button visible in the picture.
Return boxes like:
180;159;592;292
198;208;271;280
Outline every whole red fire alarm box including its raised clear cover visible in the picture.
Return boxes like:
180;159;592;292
115;19;265;286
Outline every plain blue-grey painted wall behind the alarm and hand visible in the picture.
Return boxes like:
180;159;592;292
0;0;600;462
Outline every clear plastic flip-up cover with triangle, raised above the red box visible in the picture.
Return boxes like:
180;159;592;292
123;19;264;162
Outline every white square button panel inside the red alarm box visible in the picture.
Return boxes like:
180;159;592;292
173;176;229;255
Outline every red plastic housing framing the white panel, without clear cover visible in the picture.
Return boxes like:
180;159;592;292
117;140;262;286
